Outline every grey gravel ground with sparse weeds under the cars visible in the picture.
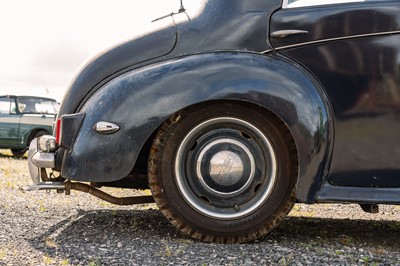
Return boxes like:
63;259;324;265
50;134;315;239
0;150;400;266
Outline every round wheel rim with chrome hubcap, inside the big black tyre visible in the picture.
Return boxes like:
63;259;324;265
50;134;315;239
175;117;277;219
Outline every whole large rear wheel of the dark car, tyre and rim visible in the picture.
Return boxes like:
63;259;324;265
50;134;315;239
148;103;297;243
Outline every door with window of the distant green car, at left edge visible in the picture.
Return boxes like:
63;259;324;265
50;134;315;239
0;97;21;148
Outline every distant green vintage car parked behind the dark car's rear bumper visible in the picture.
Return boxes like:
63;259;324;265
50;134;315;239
0;95;59;157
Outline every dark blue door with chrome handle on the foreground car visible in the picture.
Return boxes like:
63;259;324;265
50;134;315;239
270;0;400;187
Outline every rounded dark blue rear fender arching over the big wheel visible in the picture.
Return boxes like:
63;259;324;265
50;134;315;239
62;52;332;202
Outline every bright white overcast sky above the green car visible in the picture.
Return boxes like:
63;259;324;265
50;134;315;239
0;0;184;101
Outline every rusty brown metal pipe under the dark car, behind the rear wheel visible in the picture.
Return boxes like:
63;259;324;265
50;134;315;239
65;181;154;205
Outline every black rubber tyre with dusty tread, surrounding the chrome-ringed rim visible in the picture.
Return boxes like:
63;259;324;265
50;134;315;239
150;104;295;240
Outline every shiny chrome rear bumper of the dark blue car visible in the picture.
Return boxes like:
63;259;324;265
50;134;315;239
28;135;55;184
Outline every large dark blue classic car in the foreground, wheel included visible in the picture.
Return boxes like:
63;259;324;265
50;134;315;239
29;0;400;243
